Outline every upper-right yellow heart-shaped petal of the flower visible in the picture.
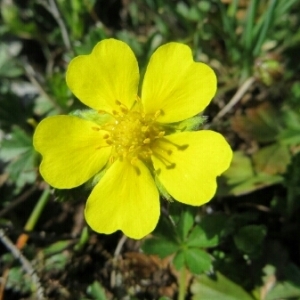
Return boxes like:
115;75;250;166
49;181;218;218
142;43;217;123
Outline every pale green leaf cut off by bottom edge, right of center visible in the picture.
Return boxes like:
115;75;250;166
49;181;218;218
191;272;254;300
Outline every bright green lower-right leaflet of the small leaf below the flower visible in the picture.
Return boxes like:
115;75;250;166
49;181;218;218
184;248;211;274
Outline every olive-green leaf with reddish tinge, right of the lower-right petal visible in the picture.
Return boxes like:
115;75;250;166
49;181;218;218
253;143;291;175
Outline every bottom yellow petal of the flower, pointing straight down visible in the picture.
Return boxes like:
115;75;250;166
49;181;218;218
85;160;160;239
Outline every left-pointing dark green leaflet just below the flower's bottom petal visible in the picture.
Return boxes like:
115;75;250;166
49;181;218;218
142;237;179;258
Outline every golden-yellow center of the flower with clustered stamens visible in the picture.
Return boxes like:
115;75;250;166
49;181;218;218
104;106;165;161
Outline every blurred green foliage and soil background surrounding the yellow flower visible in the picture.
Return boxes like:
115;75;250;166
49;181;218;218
0;0;300;300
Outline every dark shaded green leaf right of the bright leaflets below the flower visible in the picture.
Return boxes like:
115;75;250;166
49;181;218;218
233;225;267;255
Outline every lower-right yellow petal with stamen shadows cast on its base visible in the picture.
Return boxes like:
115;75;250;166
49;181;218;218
152;130;232;205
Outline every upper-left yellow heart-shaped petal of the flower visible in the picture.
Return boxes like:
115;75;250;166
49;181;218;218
67;39;139;113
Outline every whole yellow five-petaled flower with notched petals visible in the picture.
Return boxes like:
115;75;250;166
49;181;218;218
34;39;232;239
